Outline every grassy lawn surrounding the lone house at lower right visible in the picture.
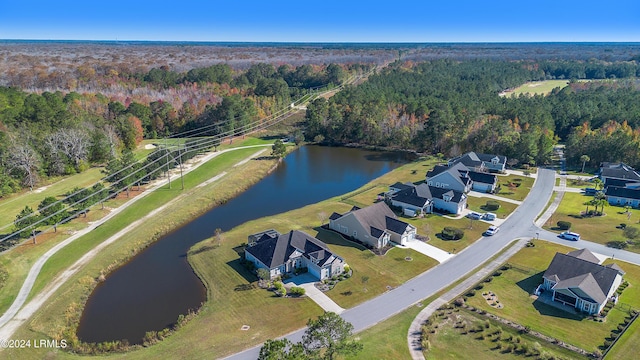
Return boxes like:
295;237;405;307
460;241;640;351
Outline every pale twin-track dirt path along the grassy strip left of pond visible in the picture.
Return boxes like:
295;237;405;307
0;144;271;344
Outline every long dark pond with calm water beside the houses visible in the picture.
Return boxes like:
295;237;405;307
78;146;406;344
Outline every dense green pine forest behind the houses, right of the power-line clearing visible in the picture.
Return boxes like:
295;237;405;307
306;60;640;170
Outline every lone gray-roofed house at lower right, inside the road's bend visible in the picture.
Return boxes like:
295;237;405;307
541;249;624;314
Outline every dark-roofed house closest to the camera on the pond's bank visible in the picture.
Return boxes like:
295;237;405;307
244;229;345;280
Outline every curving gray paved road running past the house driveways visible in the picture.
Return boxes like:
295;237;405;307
229;169;555;359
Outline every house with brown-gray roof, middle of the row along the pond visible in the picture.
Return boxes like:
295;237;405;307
329;201;416;248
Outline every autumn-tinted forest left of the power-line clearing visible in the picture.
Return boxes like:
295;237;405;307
0;63;356;197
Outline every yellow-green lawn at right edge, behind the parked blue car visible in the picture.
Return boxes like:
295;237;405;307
544;193;640;252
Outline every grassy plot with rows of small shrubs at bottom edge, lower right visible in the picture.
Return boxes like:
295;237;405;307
425;309;584;360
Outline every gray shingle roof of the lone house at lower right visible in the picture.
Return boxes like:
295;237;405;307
543;251;618;303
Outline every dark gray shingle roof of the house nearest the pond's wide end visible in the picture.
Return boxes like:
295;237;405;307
245;230;334;269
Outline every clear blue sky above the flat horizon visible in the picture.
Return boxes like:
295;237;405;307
0;0;640;42
